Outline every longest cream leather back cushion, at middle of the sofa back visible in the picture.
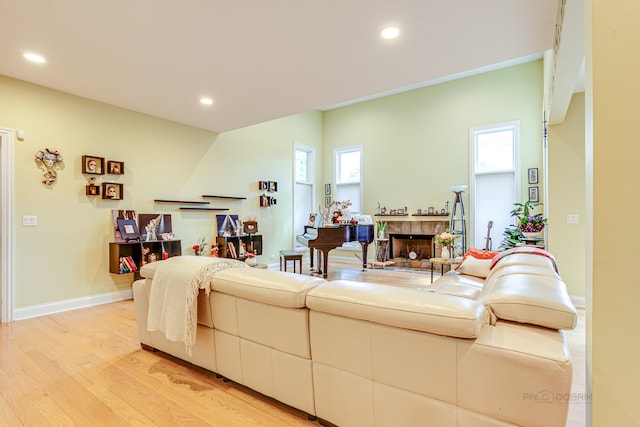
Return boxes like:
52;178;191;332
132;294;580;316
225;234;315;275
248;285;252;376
307;280;488;338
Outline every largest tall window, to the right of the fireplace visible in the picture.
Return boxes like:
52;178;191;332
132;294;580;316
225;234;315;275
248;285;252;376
470;121;520;250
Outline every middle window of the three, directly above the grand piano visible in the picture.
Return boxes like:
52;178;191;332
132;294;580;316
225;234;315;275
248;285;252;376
333;147;362;212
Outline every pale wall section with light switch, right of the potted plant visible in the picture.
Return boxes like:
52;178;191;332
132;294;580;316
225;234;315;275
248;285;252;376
548;92;587;298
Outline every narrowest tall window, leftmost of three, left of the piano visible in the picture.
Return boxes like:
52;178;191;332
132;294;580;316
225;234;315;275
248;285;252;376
293;144;317;246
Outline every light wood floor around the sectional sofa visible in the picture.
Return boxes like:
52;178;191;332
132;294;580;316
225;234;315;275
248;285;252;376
0;262;585;427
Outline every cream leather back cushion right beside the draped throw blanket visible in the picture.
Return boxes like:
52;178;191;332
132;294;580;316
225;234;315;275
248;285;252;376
211;268;326;308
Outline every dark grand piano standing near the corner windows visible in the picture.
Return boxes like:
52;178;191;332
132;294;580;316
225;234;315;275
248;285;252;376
296;224;373;279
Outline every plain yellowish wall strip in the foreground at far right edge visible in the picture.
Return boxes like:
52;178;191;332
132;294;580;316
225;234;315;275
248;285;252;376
585;0;640;427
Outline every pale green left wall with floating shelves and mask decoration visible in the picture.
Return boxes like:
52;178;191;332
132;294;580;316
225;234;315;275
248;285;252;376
0;76;321;309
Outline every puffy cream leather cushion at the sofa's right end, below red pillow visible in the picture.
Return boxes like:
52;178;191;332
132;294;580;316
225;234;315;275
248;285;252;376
479;273;578;329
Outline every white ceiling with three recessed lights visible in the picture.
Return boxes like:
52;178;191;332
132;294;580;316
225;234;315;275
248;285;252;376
0;0;558;132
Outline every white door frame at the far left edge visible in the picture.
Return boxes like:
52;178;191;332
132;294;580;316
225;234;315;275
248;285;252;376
0;128;15;323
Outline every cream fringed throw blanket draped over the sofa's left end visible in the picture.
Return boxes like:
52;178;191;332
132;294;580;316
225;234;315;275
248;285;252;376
147;256;247;356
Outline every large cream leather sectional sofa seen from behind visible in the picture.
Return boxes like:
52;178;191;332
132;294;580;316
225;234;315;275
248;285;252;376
133;247;577;427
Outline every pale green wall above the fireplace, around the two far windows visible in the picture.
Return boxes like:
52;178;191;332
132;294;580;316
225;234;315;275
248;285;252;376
323;60;544;247
